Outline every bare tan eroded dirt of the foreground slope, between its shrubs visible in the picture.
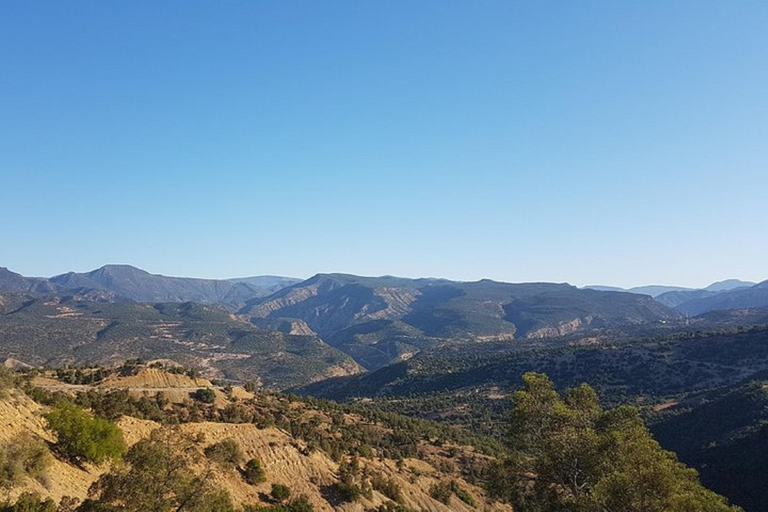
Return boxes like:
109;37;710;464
0;388;510;512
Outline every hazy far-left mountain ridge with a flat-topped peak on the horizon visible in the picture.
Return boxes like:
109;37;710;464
0;265;298;307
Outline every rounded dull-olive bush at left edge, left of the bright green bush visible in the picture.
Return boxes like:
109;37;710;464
0;433;51;488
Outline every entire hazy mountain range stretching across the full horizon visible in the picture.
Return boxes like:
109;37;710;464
0;265;768;370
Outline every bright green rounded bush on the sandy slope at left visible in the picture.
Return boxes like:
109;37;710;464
45;403;125;464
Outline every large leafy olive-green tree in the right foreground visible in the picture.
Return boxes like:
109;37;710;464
491;373;739;512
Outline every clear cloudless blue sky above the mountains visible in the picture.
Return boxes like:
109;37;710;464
0;0;768;286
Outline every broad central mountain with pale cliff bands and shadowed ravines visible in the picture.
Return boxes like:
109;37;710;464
239;274;679;369
